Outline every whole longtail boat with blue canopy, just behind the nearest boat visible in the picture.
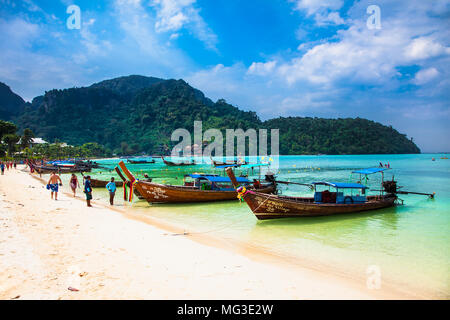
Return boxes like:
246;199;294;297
115;161;276;203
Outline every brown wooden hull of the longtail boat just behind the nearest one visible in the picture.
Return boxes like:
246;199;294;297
134;181;276;203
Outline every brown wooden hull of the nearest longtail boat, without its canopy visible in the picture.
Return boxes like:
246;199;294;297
243;191;397;220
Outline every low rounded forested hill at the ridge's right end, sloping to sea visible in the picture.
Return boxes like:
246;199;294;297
263;117;420;154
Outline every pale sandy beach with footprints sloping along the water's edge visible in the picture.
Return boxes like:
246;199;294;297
0;166;411;299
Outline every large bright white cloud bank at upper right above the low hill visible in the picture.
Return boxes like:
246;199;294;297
252;1;450;87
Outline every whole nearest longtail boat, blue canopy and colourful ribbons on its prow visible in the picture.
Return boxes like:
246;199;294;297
226;168;397;220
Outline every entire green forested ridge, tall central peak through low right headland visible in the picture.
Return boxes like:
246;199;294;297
0;76;420;154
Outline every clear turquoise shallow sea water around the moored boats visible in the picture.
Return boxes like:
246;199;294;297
75;154;450;298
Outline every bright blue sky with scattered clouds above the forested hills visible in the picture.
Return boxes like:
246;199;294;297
0;0;450;152
